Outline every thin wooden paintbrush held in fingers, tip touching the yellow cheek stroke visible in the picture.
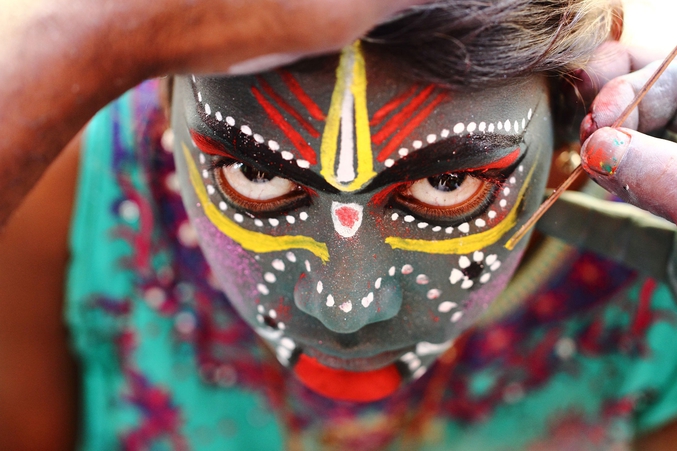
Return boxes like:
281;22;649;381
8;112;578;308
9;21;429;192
505;43;677;250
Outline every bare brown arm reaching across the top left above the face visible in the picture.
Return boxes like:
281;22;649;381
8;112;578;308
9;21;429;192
0;0;421;226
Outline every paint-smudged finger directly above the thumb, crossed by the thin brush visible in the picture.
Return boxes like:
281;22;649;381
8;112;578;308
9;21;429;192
581;61;677;141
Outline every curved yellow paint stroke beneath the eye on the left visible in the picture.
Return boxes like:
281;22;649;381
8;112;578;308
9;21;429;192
182;143;329;263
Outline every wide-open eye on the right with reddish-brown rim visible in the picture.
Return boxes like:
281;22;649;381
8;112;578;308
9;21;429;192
391;172;494;225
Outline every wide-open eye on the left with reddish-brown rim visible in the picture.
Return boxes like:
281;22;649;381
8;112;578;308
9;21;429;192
213;158;310;217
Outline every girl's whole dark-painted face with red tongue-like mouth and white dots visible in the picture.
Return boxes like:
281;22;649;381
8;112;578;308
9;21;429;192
172;44;552;401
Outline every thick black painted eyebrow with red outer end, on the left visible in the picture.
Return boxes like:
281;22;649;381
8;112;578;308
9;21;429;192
189;130;339;194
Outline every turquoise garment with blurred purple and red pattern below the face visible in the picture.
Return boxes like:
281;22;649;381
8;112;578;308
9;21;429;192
66;82;677;451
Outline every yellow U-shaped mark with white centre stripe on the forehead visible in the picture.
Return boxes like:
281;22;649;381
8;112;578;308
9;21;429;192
320;41;376;192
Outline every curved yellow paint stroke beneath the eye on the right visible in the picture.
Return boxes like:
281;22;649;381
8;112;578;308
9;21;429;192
385;162;537;254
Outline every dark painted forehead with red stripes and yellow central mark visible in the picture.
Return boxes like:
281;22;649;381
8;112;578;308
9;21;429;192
182;44;545;191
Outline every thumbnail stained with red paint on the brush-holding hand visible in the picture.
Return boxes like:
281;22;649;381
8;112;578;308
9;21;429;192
581;127;631;177
